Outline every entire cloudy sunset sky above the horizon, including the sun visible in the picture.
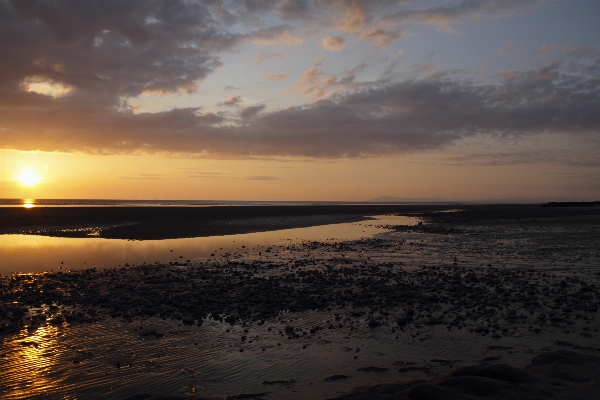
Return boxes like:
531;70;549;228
0;0;600;201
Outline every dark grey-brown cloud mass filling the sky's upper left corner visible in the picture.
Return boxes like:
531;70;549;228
0;0;241;103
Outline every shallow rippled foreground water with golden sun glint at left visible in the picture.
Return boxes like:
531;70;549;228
0;304;596;399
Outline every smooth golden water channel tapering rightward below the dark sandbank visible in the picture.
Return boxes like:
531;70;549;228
0;216;419;275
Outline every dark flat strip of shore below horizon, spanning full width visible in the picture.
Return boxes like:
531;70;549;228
0;204;600;240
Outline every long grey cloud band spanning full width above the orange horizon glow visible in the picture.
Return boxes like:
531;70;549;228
2;60;600;160
